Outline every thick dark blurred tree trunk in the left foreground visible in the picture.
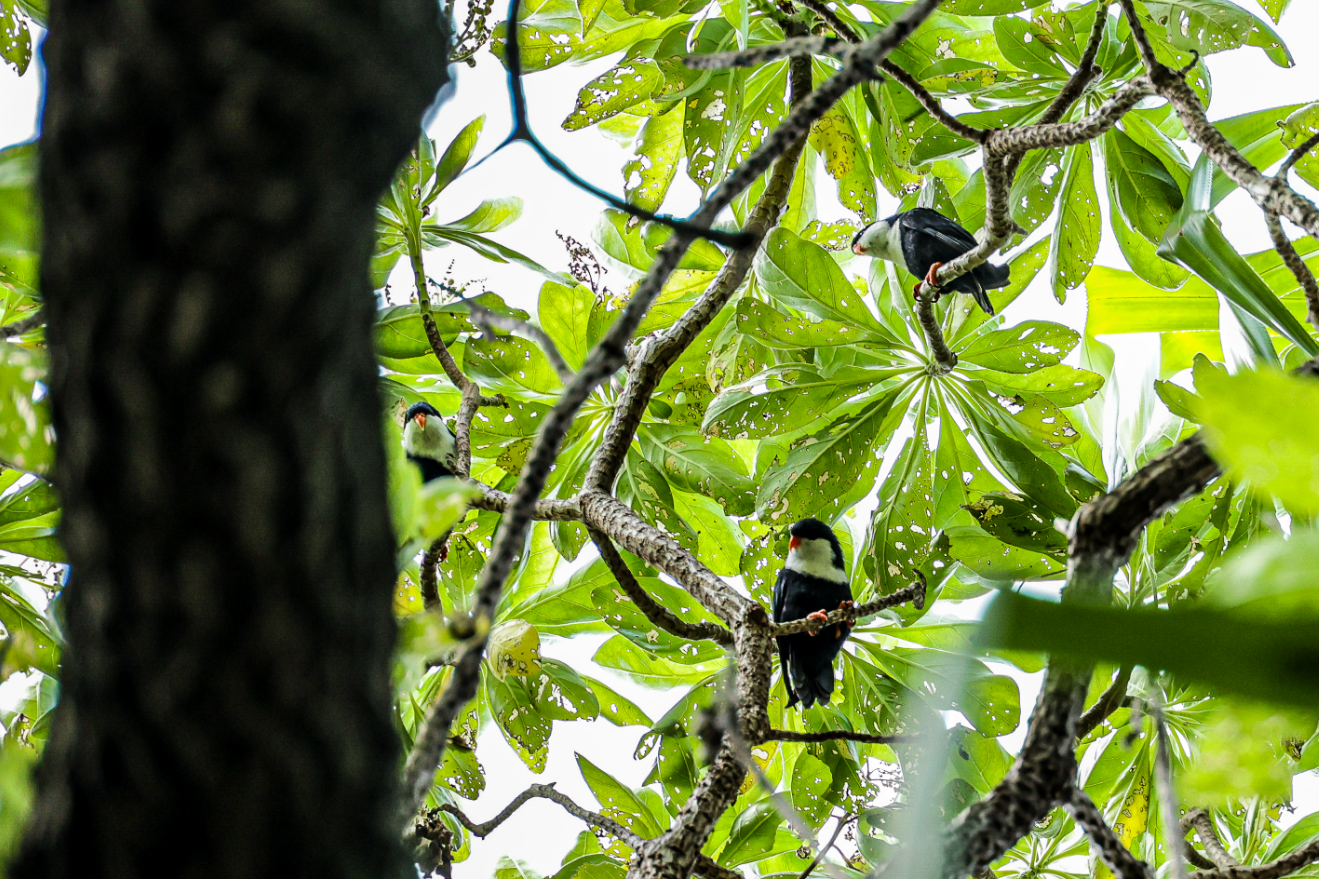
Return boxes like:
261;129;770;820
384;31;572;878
13;0;447;879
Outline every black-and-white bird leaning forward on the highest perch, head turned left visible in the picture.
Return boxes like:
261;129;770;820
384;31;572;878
852;207;1009;314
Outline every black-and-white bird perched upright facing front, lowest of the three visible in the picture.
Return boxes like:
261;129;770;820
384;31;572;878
774;519;852;707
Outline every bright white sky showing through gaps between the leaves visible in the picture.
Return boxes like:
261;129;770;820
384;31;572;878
0;0;1319;879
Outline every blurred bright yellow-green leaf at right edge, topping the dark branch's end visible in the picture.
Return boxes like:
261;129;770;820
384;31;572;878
1195;370;1319;513
